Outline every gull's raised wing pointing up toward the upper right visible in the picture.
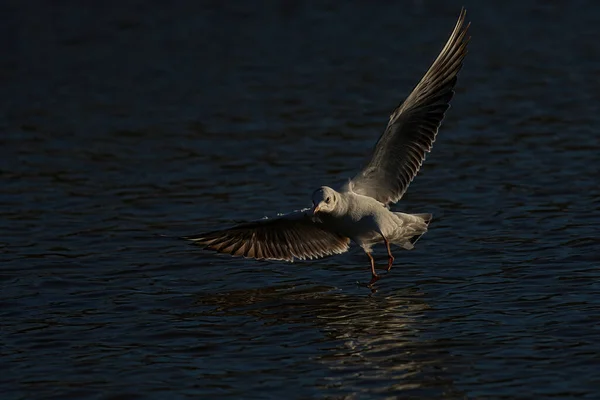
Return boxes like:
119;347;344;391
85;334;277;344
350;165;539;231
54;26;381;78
350;9;469;204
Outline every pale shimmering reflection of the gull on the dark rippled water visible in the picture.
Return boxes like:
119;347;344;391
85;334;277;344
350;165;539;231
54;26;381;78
198;285;464;398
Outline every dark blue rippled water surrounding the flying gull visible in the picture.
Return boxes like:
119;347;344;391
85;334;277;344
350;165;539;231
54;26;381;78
0;0;600;399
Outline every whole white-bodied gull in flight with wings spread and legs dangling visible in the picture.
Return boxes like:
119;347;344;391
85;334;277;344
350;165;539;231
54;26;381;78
184;9;470;285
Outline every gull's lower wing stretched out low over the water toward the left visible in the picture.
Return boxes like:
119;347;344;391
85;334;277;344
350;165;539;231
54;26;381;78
184;211;350;261
